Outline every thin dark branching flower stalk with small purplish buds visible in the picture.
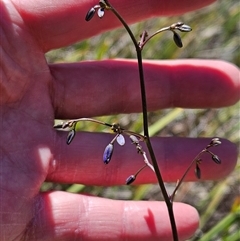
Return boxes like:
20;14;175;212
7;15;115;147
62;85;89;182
54;0;221;241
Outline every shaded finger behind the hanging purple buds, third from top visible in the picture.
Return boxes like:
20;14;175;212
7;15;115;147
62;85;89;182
46;132;237;186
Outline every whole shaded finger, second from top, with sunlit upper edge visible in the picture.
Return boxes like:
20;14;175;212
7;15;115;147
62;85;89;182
50;60;240;119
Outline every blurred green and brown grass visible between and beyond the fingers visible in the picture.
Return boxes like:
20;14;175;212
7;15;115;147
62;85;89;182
42;0;240;241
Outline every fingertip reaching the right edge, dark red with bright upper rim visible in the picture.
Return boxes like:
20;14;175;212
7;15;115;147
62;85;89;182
170;59;240;108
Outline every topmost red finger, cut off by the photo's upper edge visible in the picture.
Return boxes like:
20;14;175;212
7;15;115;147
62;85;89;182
14;0;214;51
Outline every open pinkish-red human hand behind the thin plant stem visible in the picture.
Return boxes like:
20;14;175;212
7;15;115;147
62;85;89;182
0;0;240;241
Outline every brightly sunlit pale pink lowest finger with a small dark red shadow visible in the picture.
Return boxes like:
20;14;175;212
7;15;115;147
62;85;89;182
28;192;198;241
